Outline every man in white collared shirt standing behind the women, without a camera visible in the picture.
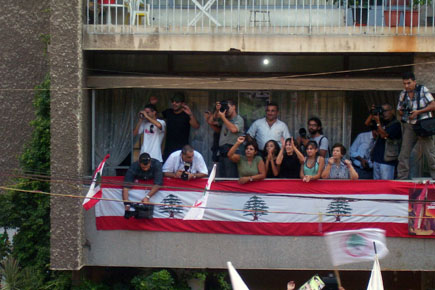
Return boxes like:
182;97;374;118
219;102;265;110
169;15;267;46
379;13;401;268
247;103;291;150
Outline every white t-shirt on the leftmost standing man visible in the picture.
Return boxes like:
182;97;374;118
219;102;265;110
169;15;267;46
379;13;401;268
138;119;166;162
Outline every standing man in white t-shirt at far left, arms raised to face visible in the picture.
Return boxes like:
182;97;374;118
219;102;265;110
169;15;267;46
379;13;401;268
133;104;166;162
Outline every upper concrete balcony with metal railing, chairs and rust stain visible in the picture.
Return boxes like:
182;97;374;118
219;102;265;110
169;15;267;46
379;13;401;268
84;0;435;52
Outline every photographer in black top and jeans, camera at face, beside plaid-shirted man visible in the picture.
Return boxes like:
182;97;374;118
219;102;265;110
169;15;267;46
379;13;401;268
365;104;402;180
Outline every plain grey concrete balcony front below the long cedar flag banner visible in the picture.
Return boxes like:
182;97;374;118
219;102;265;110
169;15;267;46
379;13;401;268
84;210;435;271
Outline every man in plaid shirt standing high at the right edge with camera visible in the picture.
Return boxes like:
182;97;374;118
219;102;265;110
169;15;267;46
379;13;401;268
397;72;435;179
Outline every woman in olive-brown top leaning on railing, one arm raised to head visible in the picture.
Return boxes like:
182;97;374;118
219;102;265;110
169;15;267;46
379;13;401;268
228;136;266;184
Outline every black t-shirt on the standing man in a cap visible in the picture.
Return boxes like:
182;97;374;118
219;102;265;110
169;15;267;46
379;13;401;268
162;109;190;160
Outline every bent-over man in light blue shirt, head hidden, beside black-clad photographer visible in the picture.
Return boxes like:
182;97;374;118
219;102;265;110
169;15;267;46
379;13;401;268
350;129;377;179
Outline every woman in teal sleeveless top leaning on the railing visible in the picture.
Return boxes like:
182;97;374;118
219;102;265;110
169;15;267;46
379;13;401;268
300;141;325;182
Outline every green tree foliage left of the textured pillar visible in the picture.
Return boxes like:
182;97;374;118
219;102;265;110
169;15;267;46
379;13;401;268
0;76;62;289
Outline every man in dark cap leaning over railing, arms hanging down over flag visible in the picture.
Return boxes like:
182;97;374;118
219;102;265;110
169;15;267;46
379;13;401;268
122;153;163;211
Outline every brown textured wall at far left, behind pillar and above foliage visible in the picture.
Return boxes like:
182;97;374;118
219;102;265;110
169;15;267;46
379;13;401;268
0;0;50;184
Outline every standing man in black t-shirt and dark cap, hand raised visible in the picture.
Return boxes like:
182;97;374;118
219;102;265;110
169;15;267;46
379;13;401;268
162;93;199;160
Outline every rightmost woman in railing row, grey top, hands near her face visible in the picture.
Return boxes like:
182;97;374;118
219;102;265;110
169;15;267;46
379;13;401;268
322;143;358;180
